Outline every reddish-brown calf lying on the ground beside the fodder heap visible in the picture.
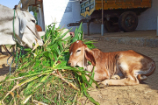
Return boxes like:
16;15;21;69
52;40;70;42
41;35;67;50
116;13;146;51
68;40;156;86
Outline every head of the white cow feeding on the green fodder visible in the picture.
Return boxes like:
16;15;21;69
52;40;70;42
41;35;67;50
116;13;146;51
14;1;45;48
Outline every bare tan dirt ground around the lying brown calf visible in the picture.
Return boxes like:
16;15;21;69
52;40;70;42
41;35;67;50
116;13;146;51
0;31;158;105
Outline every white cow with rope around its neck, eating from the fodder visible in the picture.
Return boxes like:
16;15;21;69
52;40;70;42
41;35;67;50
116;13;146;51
0;1;45;48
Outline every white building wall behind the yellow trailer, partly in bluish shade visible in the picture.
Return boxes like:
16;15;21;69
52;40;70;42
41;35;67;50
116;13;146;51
43;0;158;34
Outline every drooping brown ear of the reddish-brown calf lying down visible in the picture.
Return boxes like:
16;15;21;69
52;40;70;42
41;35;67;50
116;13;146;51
85;48;96;66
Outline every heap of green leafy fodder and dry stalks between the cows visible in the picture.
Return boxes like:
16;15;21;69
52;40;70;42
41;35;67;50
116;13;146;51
0;24;98;105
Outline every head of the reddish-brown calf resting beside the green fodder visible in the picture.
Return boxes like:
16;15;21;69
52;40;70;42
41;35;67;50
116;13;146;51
68;40;95;67
